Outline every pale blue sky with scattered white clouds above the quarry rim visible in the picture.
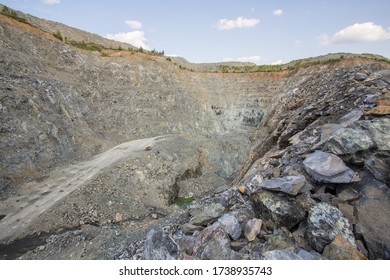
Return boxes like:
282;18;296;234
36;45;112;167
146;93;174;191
0;0;390;64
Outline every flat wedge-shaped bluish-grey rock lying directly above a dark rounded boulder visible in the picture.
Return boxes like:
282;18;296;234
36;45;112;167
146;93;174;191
253;175;306;196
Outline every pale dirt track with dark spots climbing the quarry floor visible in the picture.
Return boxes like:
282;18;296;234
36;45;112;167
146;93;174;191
0;136;167;243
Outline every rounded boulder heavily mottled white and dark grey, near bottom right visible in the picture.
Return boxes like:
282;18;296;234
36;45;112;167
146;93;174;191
306;202;356;252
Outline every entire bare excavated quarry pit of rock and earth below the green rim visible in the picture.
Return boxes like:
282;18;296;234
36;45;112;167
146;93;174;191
0;10;390;259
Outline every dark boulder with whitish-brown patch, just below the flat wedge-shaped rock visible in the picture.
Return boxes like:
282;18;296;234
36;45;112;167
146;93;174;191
251;190;306;229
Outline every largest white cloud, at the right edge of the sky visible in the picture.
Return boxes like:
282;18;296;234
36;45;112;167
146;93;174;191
317;22;390;45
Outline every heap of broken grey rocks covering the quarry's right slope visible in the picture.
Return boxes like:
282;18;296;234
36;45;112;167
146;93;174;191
119;65;390;259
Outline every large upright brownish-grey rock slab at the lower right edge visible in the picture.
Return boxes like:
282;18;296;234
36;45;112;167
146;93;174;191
355;174;390;259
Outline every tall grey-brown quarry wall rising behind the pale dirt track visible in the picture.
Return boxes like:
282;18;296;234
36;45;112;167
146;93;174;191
0;12;287;192
